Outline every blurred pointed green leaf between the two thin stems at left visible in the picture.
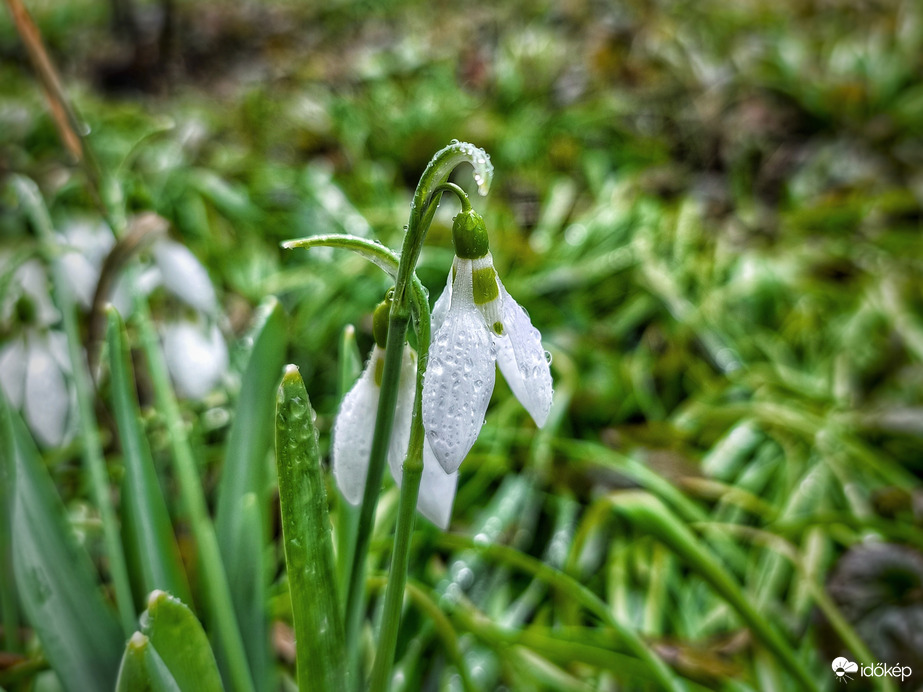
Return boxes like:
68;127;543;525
106;307;190;601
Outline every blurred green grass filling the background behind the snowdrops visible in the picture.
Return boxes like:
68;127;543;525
0;0;923;689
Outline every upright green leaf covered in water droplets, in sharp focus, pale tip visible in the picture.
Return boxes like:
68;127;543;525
276;365;348;691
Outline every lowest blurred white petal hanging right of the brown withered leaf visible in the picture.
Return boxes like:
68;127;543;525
163;322;228;399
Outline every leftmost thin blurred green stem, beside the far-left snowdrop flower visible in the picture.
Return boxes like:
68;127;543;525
13;176;136;637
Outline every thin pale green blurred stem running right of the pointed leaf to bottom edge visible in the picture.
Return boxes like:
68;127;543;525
134;295;254;692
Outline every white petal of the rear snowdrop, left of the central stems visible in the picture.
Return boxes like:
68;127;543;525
331;346;384;505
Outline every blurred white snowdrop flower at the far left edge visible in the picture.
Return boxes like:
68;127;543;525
0;260;75;447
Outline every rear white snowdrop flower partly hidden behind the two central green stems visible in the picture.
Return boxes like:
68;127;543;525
332;301;458;529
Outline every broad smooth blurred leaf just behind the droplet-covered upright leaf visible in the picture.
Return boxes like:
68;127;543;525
215;298;286;687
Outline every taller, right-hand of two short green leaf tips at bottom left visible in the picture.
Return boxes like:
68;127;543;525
141;591;224;692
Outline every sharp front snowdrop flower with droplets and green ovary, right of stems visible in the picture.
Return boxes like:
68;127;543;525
423;207;552;473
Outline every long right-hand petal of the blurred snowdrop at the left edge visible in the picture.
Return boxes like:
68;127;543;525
23;339;70;447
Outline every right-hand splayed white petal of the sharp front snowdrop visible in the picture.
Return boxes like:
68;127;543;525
496;284;553;427
